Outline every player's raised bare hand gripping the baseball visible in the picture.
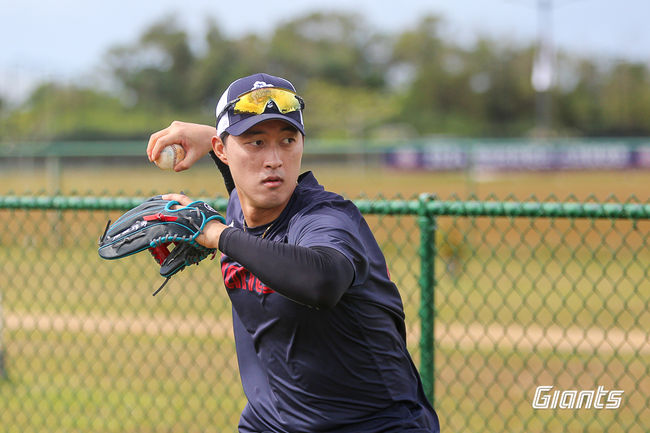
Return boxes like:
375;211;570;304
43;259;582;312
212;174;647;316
147;120;217;171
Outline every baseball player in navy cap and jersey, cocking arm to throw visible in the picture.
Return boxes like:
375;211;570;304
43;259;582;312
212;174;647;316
147;74;439;432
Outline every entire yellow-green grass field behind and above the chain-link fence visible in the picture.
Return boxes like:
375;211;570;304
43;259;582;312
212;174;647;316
0;166;650;432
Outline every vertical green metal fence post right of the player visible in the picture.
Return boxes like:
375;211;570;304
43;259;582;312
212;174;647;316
418;194;436;404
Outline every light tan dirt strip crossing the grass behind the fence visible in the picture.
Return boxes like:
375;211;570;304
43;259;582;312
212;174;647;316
6;313;650;355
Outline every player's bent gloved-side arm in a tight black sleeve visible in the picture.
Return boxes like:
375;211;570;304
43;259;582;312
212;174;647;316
219;228;354;308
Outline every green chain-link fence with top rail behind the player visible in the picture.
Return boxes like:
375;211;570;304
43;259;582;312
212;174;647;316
0;196;650;433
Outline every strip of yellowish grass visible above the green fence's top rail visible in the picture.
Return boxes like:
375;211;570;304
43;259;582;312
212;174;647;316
0;162;650;201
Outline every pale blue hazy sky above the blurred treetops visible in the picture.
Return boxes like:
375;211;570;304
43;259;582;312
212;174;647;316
0;0;650;98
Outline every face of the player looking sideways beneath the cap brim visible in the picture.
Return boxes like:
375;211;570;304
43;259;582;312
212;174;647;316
215;119;304;218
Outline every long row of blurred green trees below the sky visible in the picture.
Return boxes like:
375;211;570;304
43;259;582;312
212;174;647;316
0;12;650;140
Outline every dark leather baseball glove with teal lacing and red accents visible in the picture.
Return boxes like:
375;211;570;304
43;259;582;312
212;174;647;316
99;196;225;296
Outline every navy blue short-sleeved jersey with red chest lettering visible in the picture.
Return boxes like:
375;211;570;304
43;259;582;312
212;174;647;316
222;172;439;432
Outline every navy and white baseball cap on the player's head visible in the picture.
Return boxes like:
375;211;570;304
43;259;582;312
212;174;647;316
216;73;305;135
